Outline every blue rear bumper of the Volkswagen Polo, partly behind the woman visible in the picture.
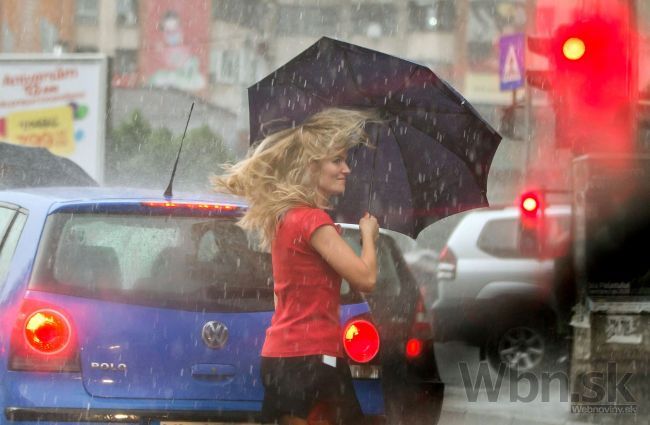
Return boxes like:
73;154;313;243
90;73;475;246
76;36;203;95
0;372;385;425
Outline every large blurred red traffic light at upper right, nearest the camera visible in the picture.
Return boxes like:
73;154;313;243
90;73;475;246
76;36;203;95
527;13;634;153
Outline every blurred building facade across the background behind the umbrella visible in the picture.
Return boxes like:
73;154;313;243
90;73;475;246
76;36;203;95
0;0;556;201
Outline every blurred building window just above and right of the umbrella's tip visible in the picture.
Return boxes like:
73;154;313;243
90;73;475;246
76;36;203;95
351;3;397;38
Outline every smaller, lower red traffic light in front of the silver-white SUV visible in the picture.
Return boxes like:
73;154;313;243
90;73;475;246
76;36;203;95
518;191;545;257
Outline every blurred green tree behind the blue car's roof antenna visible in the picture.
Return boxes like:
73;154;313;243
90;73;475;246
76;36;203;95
106;110;235;191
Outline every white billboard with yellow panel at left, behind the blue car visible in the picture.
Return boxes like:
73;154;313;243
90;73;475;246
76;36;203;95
0;55;108;182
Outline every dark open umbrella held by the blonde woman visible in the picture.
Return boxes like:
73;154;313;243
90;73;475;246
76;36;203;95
248;37;501;237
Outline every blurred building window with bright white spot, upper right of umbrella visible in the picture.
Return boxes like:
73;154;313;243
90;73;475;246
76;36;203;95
409;0;456;32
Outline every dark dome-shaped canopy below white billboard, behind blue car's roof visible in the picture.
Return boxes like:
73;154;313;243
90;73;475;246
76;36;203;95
0;142;97;189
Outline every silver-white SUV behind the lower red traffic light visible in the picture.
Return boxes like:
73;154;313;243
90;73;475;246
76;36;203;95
433;205;571;373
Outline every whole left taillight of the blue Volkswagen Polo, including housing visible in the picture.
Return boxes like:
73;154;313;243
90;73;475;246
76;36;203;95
9;300;81;372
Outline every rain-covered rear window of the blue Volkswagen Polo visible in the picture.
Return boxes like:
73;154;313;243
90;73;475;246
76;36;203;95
30;213;358;311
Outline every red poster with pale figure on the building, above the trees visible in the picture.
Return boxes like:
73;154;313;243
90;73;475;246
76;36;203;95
140;0;210;92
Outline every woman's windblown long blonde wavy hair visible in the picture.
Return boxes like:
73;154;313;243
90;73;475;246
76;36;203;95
212;108;375;249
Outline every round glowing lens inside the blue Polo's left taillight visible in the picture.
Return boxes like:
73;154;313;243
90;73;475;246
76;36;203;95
25;310;70;354
